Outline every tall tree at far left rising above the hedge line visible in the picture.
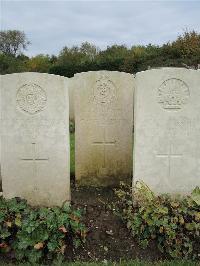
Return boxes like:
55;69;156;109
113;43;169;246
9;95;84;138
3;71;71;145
0;30;30;56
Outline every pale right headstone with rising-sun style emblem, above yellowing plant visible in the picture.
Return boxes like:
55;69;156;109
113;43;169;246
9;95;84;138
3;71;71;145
133;68;200;194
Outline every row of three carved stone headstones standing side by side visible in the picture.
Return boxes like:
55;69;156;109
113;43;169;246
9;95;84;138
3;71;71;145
0;68;200;206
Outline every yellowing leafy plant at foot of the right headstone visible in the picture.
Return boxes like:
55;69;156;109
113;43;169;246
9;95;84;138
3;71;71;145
115;182;200;259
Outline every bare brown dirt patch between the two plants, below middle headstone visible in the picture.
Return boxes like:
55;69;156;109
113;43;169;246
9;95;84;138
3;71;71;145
71;187;165;261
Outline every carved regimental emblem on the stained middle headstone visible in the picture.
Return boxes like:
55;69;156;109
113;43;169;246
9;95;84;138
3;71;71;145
94;75;116;104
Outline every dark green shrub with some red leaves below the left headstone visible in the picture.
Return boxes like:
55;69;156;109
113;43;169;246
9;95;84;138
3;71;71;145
0;198;86;263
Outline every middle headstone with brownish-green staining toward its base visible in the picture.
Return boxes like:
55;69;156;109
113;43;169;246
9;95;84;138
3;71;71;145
75;71;134;186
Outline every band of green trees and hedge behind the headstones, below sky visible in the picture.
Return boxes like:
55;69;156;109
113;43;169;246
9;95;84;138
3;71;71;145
0;31;200;77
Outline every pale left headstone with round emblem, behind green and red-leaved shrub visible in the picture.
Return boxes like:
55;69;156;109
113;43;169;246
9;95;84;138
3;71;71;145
1;73;70;206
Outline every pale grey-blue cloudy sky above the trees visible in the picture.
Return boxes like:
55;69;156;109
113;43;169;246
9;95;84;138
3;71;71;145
0;0;200;56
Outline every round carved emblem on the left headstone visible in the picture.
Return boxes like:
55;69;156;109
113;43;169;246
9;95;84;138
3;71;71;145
16;84;47;114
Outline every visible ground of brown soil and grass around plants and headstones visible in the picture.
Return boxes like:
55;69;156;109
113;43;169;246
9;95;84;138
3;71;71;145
0;133;200;266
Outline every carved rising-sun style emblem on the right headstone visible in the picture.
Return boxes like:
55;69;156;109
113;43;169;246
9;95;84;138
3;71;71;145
158;78;190;110
